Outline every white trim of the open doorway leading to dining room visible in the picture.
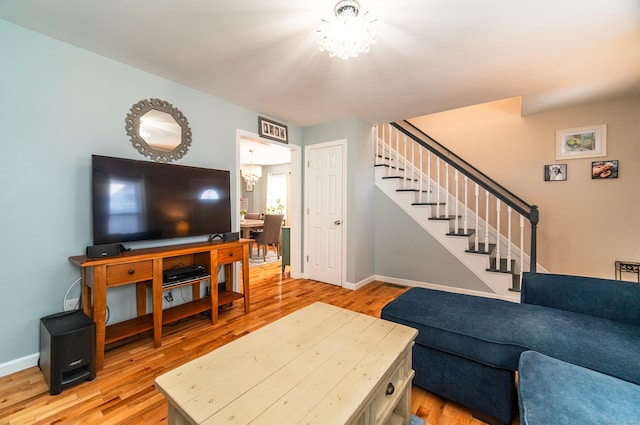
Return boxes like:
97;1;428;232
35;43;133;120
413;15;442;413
238;129;302;278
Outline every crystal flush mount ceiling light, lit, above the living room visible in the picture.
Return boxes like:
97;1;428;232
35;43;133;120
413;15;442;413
318;0;377;59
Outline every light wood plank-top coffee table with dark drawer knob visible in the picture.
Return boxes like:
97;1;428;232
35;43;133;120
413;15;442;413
156;303;417;425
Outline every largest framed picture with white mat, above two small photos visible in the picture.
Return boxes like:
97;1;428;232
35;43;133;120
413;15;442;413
556;124;607;159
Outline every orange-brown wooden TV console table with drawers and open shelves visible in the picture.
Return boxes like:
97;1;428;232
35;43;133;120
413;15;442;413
69;239;250;370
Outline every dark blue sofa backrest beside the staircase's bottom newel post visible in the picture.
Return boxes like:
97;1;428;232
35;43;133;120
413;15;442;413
520;272;640;326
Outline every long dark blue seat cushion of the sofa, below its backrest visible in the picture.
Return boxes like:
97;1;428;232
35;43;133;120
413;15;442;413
381;288;640;384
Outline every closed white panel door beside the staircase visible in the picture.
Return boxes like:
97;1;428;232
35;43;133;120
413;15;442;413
305;141;344;286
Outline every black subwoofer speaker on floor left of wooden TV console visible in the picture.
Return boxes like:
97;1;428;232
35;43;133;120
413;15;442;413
38;311;96;395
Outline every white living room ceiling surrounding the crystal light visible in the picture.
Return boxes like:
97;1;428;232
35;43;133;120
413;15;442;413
0;0;640;126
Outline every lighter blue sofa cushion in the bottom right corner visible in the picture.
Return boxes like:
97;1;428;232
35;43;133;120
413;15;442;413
518;351;640;425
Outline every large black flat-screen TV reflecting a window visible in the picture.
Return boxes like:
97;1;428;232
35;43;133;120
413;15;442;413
92;155;231;244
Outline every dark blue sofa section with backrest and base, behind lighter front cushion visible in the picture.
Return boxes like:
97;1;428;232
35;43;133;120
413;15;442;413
381;273;640;423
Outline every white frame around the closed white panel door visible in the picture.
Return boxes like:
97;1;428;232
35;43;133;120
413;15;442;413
303;139;349;288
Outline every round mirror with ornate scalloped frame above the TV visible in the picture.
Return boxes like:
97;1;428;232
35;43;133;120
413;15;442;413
125;99;191;162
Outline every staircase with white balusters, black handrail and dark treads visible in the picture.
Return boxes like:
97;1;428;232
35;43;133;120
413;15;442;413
374;121;538;298
